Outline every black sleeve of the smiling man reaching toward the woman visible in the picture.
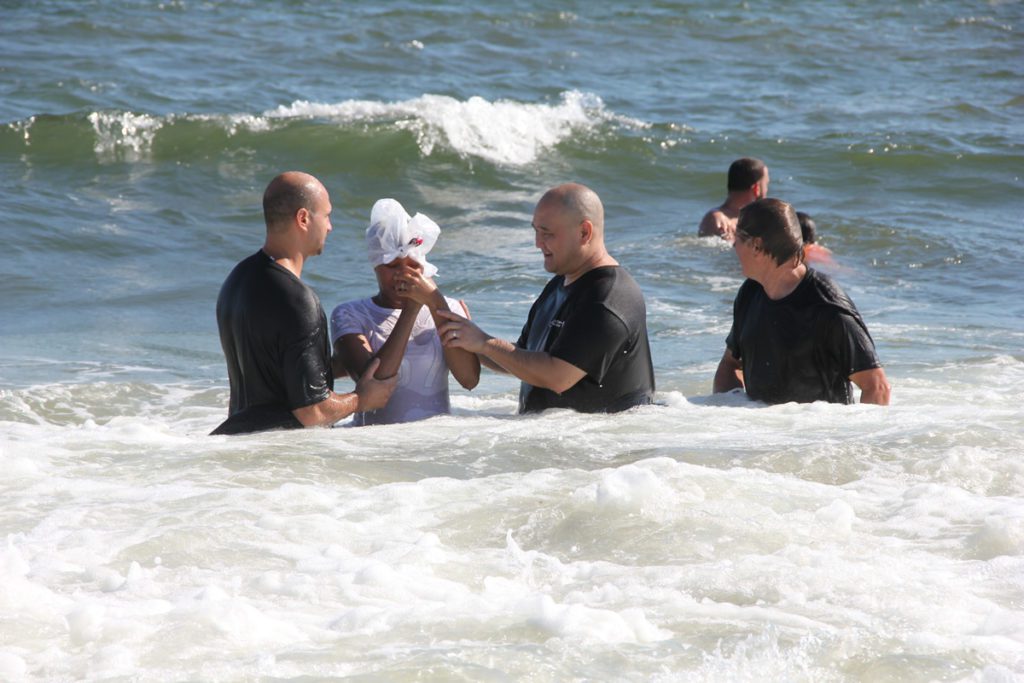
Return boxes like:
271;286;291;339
548;303;630;384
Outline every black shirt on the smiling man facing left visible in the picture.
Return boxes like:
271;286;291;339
516;266;654;413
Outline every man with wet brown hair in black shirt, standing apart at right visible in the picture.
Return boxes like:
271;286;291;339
714;199;891;405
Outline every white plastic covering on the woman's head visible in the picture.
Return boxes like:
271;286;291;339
367;199;441;278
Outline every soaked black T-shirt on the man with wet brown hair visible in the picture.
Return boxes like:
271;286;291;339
725;268;882;403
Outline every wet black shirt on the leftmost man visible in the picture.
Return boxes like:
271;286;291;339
213;250;334;434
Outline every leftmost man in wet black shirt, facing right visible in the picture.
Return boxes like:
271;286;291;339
213;171;396;434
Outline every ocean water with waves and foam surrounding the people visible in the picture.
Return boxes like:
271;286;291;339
0;0;1024;683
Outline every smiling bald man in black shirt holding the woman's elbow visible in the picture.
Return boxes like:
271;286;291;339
438;183;654;413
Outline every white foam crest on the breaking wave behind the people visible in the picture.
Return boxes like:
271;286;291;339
264;91;614;166
